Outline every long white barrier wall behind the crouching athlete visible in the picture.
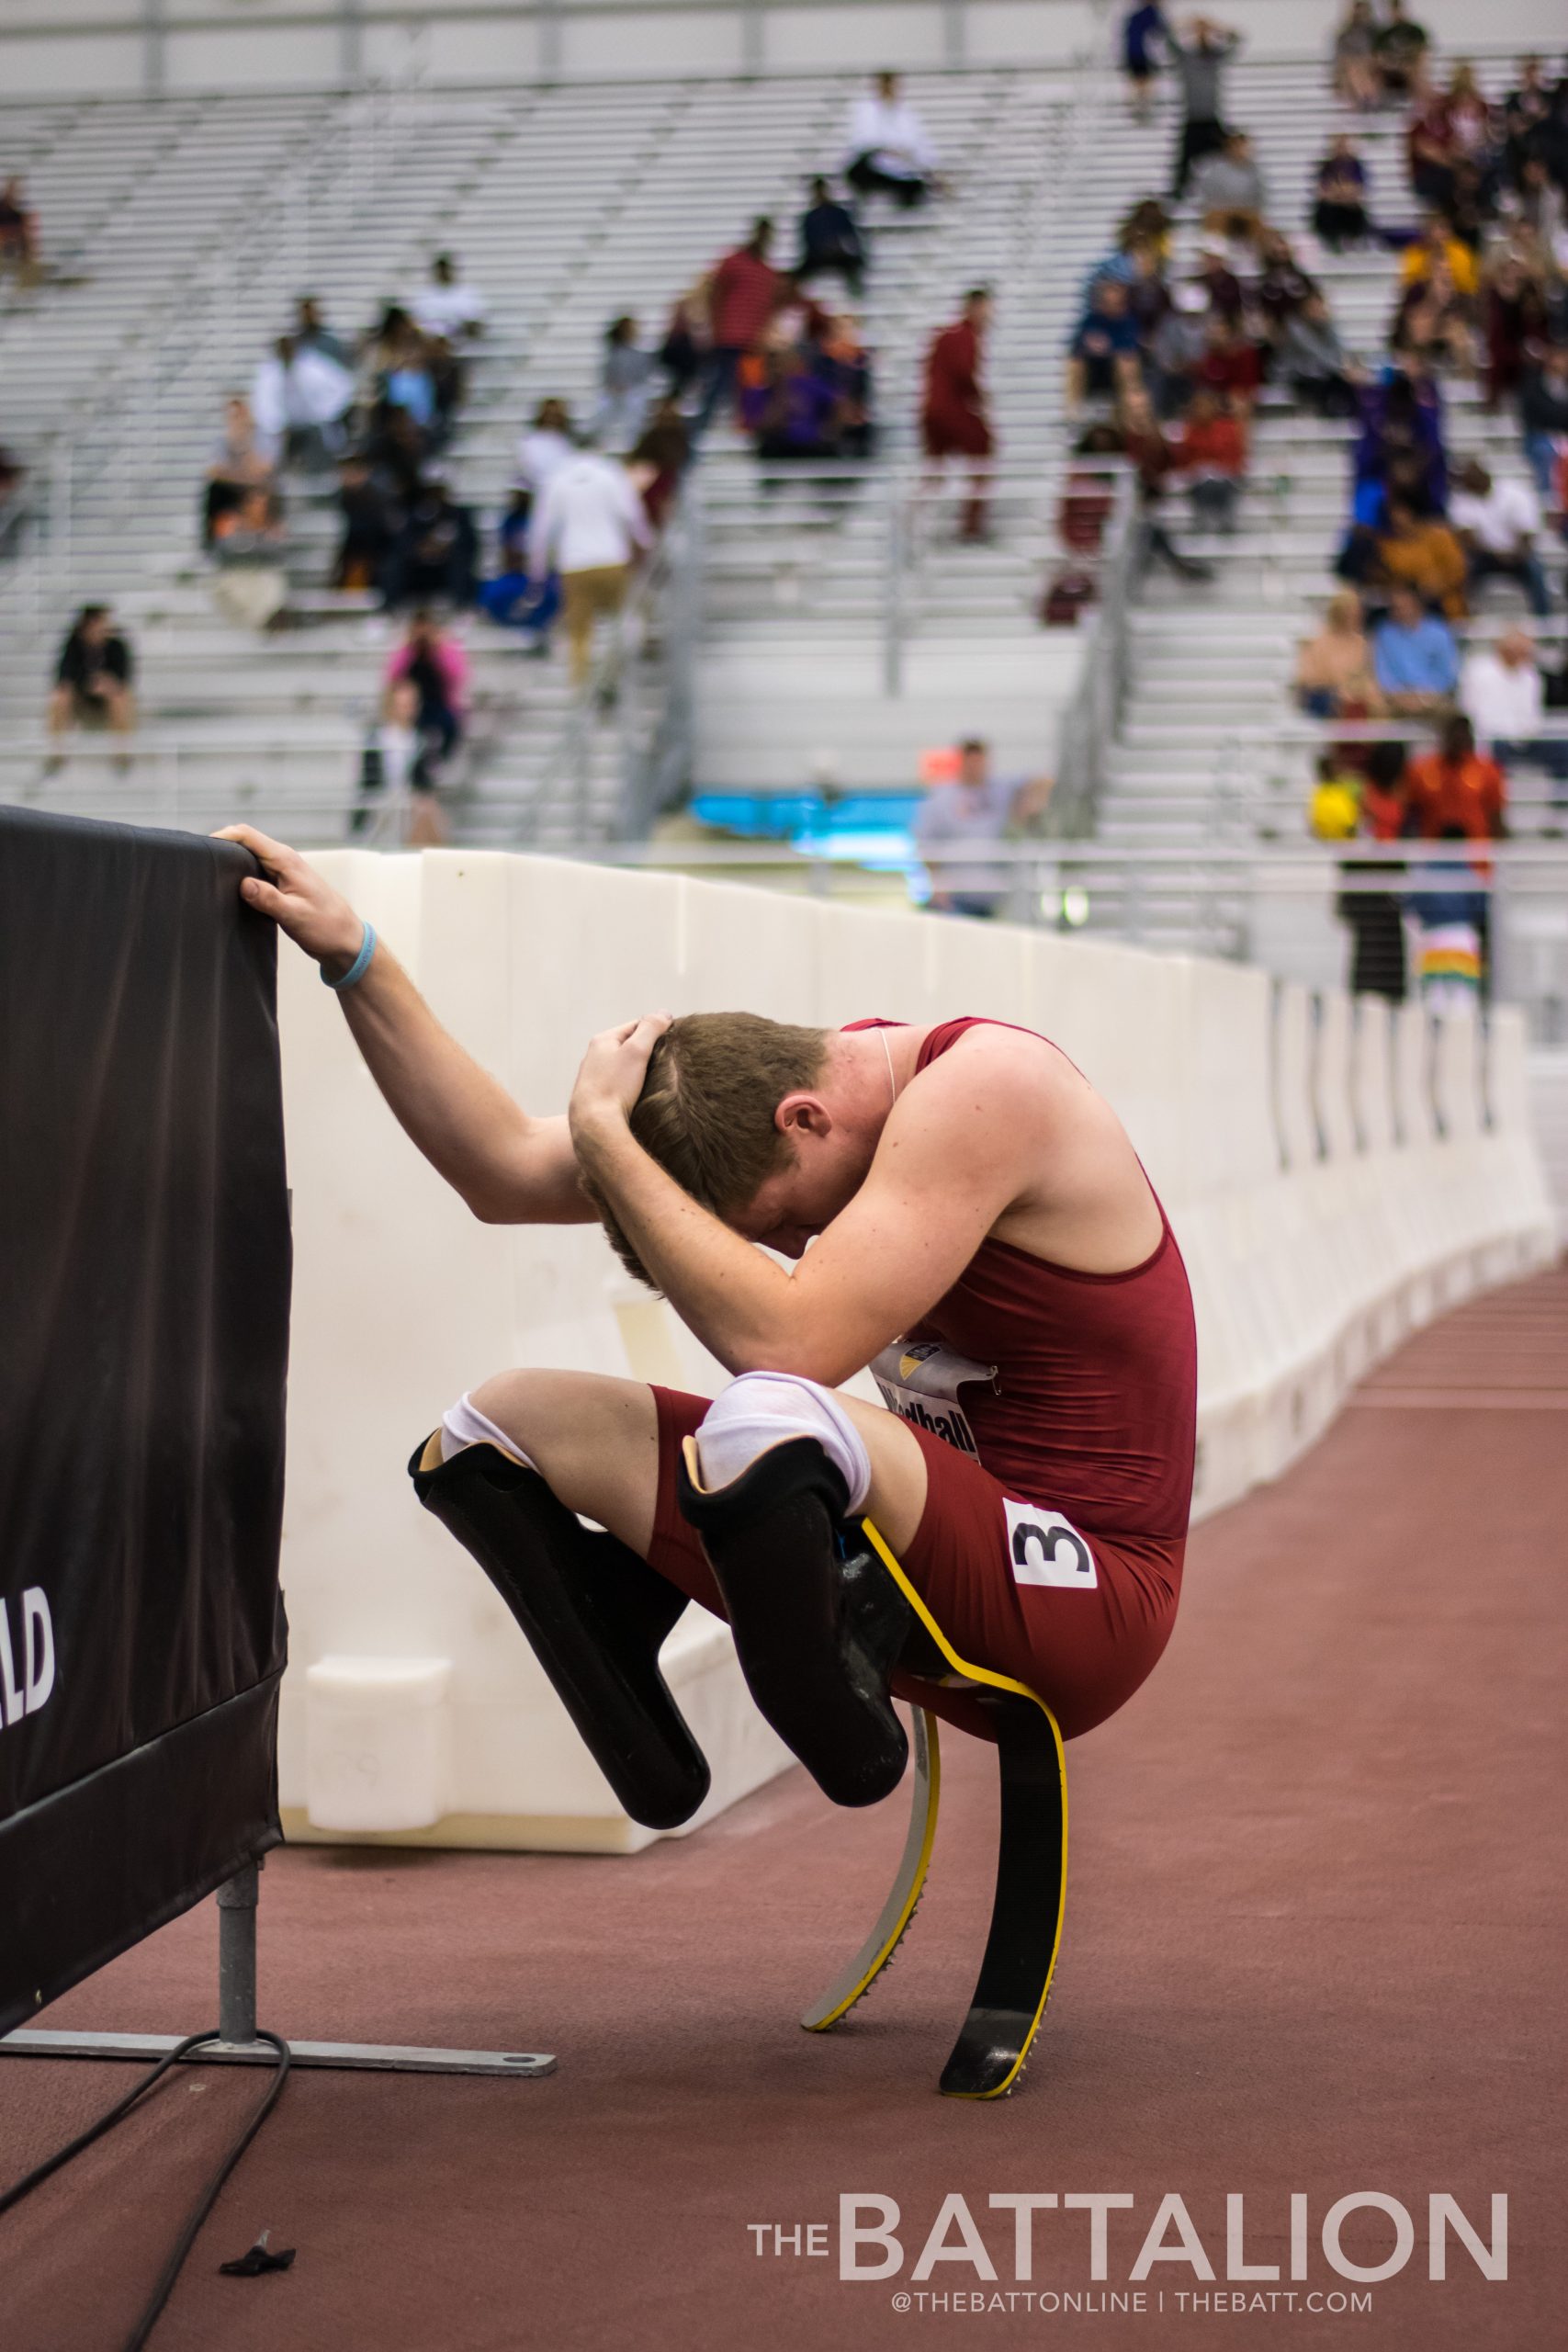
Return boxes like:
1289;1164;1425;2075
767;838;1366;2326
280;849;1551;1851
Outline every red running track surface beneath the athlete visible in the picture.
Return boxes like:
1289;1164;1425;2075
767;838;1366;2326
0;1272;1568;2352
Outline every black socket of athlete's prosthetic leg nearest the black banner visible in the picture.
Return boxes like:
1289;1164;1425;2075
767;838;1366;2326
409;1430;707;1830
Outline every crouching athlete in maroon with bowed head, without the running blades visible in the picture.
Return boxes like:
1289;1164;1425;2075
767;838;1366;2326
228;826;1194;1827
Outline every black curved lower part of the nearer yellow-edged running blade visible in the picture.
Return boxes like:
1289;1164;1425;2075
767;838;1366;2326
941;1691;1067;2098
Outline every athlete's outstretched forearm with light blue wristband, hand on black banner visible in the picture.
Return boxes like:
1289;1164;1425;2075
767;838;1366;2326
219;826;594;1226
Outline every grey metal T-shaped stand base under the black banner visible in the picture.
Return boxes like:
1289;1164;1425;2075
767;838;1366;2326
0;1863;555;2082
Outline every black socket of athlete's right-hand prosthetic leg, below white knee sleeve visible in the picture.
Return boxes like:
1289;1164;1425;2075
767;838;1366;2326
680;1437;909;1804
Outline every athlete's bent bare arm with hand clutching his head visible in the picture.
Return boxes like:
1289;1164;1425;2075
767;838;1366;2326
571;1023;1054;1387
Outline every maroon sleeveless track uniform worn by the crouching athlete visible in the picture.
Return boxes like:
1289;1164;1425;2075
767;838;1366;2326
649;1018;1197;1738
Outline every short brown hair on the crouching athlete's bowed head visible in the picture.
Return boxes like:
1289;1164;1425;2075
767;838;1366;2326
588;1013;828;1289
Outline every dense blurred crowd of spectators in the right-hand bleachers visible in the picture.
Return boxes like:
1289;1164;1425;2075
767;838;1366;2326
1104;0;1568;992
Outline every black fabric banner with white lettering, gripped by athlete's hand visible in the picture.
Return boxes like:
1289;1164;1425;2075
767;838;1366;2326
0;809;291;2032
